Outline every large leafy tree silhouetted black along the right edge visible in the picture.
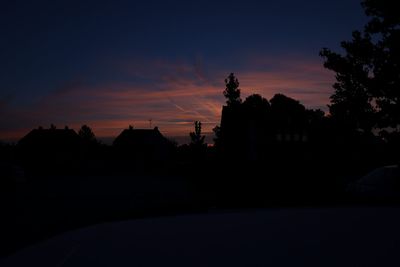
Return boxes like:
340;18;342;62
320;0;400;131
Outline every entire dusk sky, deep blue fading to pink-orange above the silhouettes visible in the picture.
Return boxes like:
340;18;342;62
0;0;367;142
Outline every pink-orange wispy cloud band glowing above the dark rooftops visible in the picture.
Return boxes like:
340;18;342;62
0;58;333;142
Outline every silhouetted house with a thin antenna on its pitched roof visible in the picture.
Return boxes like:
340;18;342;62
113;126;173;160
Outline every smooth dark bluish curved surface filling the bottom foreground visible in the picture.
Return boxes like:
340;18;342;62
1;207;400;267
